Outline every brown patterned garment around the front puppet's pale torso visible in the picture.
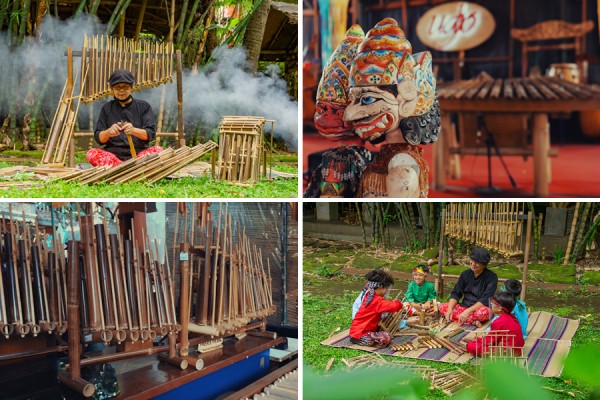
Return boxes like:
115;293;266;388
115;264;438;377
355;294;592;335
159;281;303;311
358;143;429;198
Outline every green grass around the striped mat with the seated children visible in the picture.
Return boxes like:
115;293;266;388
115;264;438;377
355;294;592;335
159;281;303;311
303;274;600;400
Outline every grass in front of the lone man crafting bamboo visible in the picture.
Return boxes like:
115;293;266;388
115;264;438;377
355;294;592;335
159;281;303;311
0;151;298;198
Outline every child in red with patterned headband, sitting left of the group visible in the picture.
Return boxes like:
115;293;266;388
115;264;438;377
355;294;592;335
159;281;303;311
350;270;402;347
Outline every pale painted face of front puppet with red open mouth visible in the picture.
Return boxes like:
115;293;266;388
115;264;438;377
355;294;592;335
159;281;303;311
344;86;400;141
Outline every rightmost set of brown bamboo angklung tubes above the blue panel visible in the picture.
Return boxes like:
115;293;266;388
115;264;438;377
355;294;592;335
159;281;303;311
175;203;275;336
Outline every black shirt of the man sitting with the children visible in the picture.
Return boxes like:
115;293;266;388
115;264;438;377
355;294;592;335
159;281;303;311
450;268;498;307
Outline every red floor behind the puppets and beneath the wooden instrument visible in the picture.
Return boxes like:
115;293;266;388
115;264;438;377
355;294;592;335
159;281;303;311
302;134;600;198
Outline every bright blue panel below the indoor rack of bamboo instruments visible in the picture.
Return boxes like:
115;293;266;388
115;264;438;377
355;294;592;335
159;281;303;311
155;349;270;400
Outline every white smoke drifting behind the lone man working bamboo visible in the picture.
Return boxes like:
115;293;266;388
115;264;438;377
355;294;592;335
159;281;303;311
0;13;298;150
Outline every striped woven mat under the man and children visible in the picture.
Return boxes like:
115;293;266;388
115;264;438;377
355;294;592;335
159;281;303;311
321;311;579;377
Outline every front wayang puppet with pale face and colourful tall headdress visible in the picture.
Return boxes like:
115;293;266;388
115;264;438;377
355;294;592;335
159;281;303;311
344;18;440;197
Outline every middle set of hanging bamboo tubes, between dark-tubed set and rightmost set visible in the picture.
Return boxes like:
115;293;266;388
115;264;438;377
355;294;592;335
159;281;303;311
78;206;181;343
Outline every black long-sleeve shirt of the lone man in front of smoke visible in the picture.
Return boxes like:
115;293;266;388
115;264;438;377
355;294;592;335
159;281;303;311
94;99;156;160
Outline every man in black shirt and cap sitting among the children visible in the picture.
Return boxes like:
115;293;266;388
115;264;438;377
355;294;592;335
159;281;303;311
439;247;498;326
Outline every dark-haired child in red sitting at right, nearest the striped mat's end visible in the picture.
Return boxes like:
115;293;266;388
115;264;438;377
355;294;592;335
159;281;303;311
467;292;525;356
